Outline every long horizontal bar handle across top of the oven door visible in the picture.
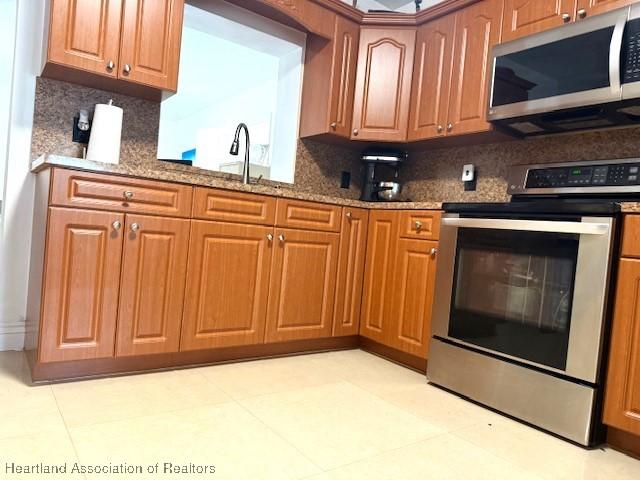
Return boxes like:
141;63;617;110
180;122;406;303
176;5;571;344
442;218;609;235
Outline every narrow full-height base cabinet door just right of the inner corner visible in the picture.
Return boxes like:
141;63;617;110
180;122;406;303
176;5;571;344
360;210;398;345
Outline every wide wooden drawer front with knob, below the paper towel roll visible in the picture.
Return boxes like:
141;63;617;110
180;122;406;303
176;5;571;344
50;168;193;217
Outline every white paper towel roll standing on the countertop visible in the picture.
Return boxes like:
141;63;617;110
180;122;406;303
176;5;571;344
87;101;122;163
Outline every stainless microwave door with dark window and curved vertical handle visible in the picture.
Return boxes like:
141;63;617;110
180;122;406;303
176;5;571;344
488;7;629;121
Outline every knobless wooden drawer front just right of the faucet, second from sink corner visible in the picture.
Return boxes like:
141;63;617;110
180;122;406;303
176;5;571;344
276;198;342;232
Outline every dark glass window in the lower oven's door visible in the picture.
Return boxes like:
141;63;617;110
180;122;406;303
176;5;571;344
449;228;579;370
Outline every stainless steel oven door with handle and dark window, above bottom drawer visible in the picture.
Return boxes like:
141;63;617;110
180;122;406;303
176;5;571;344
433;214;613;383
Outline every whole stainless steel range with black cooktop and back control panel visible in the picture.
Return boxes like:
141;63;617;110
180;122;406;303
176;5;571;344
427;159;640;445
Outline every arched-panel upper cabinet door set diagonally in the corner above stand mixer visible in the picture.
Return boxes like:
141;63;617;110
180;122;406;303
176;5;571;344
352;27;416;142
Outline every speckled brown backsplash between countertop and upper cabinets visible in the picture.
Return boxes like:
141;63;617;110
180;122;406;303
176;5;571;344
31;78;640;202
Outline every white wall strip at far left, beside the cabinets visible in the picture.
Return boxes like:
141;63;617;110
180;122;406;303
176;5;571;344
0;0;45;350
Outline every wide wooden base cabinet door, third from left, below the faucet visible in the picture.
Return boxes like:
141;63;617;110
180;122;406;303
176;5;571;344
180;220;273;350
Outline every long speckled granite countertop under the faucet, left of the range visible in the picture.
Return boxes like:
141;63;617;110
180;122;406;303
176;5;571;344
31;155;442;210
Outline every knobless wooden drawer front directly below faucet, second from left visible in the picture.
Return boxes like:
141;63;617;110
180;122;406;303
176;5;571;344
193;187;276;225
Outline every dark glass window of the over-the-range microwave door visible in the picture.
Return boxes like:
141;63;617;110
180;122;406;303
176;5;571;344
491;27;613;107
